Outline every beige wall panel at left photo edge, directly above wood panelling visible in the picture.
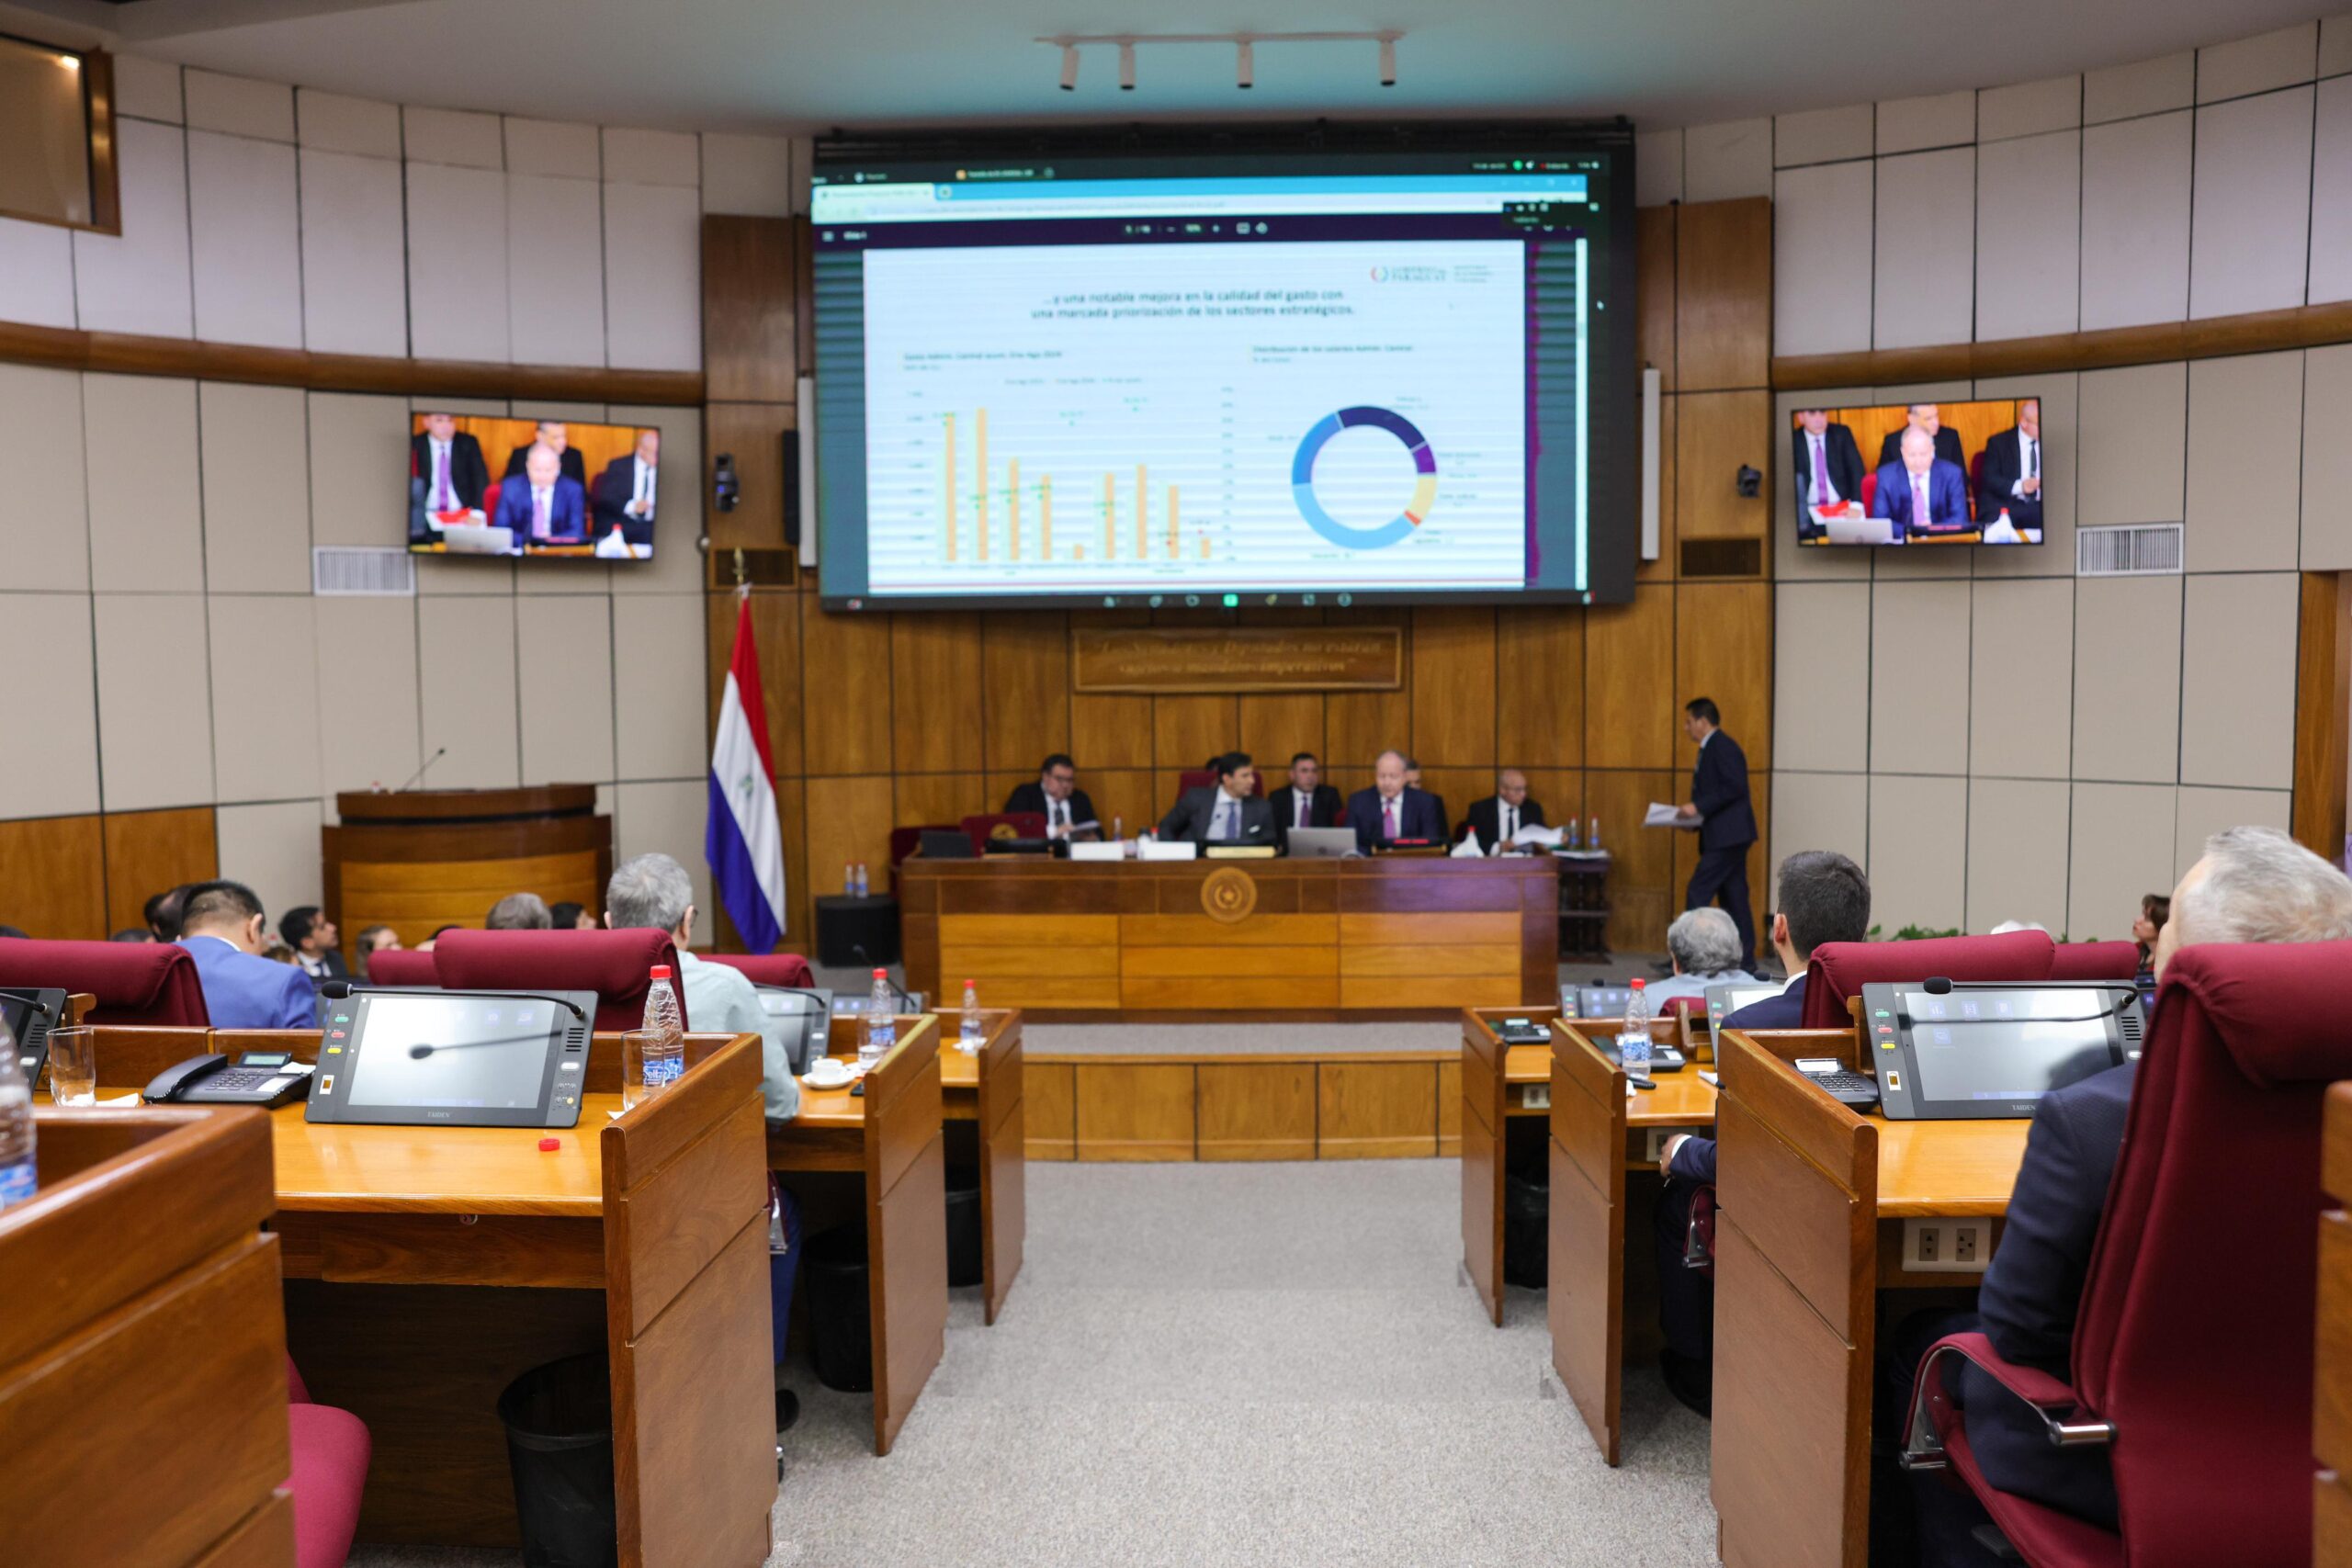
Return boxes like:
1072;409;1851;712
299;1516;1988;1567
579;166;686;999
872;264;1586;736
0;592;99;822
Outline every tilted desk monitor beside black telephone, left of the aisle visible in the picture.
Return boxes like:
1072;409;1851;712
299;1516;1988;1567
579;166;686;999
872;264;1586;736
303;989;595;1126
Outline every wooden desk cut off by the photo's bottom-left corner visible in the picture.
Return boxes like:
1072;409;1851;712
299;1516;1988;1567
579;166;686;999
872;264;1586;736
0;1105;294;1568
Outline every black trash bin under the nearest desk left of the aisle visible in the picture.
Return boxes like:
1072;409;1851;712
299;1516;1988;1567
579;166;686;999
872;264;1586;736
499;1357;621;1568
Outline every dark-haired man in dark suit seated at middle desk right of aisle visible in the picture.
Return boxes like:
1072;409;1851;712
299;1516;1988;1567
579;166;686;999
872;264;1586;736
1654;849;1870;1416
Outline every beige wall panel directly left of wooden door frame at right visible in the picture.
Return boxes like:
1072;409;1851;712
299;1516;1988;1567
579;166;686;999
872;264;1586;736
2180;571;2298;790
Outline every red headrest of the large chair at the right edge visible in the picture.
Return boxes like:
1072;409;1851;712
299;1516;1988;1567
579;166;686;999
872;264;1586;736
2157;942;2352;1089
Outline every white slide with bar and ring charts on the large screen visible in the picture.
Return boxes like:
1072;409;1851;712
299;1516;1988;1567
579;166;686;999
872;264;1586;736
865;240;1529;594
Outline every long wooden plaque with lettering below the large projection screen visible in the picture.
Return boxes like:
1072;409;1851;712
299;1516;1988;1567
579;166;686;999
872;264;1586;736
1070;626;1404;694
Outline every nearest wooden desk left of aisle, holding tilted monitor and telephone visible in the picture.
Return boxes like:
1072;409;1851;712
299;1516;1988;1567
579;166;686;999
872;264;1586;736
94;1030;776;1568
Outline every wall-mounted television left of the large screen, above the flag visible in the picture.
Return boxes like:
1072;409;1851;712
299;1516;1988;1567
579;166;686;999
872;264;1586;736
409;412;661;562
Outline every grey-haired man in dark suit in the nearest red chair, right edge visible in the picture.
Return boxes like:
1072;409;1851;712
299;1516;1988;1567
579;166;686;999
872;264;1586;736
1882;828;2352;1561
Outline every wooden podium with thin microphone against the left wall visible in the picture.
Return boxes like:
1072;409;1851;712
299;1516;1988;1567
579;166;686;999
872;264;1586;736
320;785;612;957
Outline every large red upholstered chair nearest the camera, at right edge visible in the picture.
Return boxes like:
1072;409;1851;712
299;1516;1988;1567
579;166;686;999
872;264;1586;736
1910;942;2352;1568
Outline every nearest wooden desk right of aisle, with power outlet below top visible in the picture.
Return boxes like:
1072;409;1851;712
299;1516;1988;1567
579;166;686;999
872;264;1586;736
1710;1030;2030;1568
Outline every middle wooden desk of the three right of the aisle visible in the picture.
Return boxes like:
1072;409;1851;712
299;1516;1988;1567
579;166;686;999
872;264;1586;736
1545;1018;1714;1464
